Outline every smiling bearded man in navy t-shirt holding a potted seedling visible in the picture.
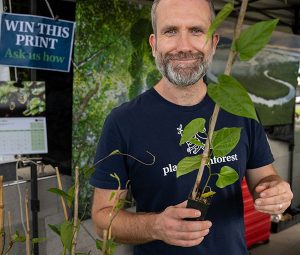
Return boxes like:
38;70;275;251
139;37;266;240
90;0;292;255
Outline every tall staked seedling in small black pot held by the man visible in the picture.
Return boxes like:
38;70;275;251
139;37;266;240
176;0;278;220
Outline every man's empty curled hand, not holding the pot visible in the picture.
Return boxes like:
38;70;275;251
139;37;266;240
254;180;293;214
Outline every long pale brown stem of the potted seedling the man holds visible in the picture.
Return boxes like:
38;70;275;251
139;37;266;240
192;0;248;200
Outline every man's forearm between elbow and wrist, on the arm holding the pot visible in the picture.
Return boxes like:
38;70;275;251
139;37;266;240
93;207;157;244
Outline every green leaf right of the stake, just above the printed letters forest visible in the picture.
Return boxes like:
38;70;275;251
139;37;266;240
212;128;241;157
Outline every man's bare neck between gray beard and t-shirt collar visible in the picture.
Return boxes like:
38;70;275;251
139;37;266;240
154;78;207;106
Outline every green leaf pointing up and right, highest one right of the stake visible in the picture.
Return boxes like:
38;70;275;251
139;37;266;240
233;19;279;61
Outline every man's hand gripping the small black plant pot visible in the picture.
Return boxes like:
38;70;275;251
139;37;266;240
153;201;212;247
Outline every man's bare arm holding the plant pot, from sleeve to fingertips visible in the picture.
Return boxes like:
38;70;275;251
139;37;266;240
92;188;212;247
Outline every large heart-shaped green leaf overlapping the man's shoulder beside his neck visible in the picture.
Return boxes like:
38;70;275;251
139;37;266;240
207;74;258;121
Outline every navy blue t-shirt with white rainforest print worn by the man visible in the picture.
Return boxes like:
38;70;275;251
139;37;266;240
90;88;273;255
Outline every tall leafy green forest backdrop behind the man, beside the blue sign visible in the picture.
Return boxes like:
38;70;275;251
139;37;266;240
72;0;156;218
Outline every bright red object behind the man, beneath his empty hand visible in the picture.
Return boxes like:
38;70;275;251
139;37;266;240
242;179;271;248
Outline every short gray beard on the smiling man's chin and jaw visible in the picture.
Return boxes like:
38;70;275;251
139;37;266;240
155;52;212;87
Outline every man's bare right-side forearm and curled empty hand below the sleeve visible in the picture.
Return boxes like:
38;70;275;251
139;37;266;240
246;164;293;214
